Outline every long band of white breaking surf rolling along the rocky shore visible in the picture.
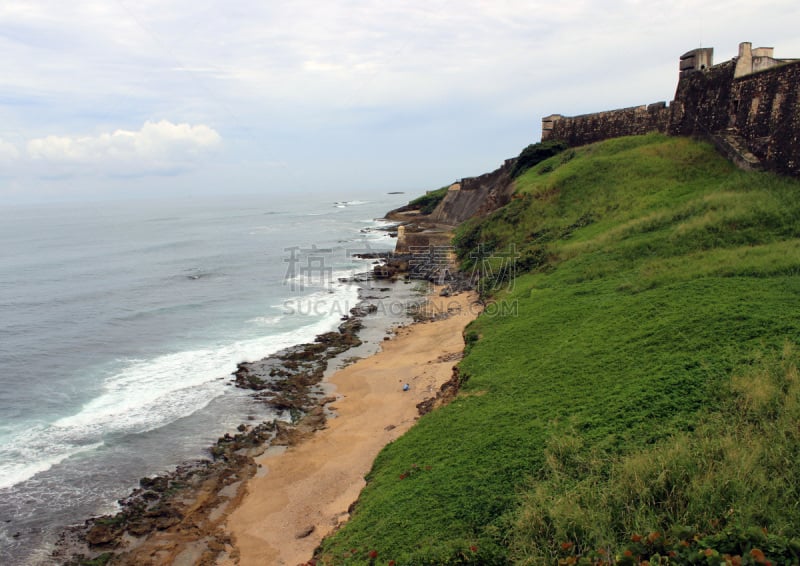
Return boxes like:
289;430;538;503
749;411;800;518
0;285;357;489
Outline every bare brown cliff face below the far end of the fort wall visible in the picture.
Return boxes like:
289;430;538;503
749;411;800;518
429;159;516;226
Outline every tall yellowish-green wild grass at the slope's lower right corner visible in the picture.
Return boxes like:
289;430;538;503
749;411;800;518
511;342;800;564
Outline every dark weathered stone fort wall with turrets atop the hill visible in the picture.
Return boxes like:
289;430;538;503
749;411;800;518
542;43;800;176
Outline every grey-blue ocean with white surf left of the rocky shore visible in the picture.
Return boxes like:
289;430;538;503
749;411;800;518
0;194;408;565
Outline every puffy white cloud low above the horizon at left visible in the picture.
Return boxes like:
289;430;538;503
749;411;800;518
26;120;222;175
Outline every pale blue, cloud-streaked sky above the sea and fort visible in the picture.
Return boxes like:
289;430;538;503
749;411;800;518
0;0;800;206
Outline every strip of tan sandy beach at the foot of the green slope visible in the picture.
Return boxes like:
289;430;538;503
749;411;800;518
226;293;478;566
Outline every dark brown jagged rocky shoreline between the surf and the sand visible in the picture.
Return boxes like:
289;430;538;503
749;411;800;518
52;278;418;566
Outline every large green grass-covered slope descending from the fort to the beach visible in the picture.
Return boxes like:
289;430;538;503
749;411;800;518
318;135;800;564
